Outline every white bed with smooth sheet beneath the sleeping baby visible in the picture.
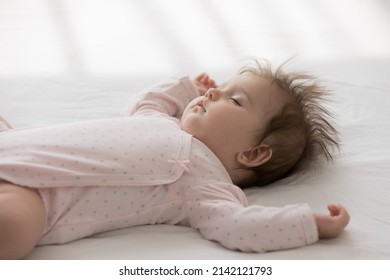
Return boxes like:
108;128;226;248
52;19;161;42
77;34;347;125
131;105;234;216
0;0;390;260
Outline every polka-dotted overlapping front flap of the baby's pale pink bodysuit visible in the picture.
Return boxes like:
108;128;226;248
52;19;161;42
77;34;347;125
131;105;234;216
0;116;191;188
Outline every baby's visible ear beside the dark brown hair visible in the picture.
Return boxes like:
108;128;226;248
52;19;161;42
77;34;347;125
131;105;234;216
237;144;272;167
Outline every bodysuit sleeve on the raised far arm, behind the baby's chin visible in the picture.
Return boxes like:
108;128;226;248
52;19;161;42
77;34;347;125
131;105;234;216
124;77;198;117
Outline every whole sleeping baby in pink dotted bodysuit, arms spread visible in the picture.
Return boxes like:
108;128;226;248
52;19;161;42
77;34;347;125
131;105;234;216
0;61;349;259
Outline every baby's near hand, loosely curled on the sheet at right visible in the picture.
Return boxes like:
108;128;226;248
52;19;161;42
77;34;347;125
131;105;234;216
314;204;349;238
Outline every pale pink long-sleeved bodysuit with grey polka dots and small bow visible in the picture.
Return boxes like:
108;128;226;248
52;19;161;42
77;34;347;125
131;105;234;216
0;77;318;252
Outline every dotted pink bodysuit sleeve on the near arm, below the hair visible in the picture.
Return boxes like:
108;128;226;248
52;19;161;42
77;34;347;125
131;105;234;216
187;186;318;252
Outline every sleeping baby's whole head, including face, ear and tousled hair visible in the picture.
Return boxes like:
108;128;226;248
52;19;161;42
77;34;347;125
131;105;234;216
182;58;338;187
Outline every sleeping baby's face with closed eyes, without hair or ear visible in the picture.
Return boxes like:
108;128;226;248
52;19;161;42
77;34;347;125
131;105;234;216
181;73;282;160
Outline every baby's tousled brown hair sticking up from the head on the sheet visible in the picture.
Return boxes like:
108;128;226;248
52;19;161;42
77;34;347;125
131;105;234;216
239;59;339;187
